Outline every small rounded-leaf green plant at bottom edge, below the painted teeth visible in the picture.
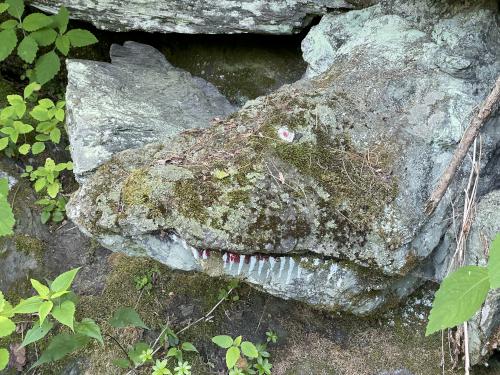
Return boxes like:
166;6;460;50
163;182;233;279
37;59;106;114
212;335;273;375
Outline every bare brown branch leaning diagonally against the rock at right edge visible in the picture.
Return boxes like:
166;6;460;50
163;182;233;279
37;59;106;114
425;76;500;215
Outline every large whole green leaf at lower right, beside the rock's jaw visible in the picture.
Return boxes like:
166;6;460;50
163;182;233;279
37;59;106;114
425;266;490;336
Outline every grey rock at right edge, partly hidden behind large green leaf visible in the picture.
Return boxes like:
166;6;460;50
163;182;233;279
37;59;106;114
466;190;500;364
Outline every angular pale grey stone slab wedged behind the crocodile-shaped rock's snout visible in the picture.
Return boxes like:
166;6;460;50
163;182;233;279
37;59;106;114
66;42;234;180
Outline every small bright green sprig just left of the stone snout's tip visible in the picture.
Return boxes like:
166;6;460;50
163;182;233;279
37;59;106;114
21;158;73;199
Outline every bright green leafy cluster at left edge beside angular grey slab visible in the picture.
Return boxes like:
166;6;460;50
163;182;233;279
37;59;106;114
0;82;66;157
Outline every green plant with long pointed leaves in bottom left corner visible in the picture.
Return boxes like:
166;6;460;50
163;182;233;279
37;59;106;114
0;268;103;370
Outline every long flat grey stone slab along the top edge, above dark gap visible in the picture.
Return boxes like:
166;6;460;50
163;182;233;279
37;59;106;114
32;0;356;34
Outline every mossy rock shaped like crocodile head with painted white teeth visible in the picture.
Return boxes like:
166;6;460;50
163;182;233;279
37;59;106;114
68;0;500;315
